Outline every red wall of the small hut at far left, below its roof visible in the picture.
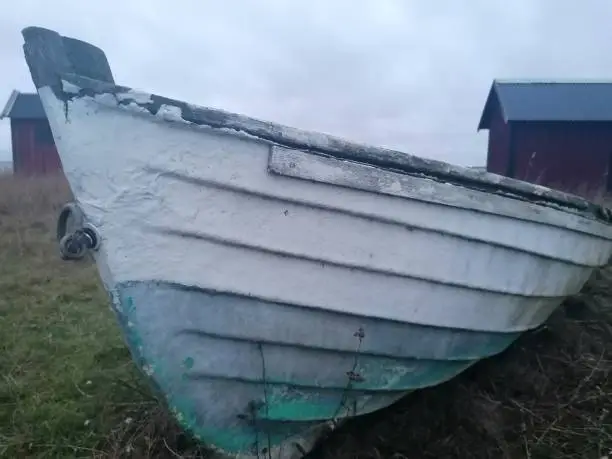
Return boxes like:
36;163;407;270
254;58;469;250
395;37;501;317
11;119;62;175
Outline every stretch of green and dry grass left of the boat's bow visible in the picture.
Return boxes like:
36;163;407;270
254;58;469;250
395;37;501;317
0;176;208;458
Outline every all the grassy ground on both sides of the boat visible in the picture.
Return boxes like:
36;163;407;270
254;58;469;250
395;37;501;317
0;176;612;459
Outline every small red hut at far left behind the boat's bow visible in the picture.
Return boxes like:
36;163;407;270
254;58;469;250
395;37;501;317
0;91;62;175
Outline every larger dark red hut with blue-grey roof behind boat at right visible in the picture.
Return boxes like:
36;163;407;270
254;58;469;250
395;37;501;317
478;80;612;198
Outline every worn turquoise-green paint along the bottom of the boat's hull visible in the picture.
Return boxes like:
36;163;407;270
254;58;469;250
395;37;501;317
113;286;518;454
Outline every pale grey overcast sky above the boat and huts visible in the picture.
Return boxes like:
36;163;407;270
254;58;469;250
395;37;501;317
0;0;612;165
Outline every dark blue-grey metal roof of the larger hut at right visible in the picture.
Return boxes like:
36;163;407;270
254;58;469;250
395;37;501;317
478;80;612;130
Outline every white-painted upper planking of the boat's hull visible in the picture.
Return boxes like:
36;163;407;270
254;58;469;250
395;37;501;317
41;89;612;332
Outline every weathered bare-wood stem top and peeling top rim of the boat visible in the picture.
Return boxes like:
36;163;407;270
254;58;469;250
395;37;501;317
22;27;612;223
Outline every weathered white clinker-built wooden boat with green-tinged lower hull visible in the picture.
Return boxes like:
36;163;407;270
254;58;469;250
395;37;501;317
23;27;612;459
